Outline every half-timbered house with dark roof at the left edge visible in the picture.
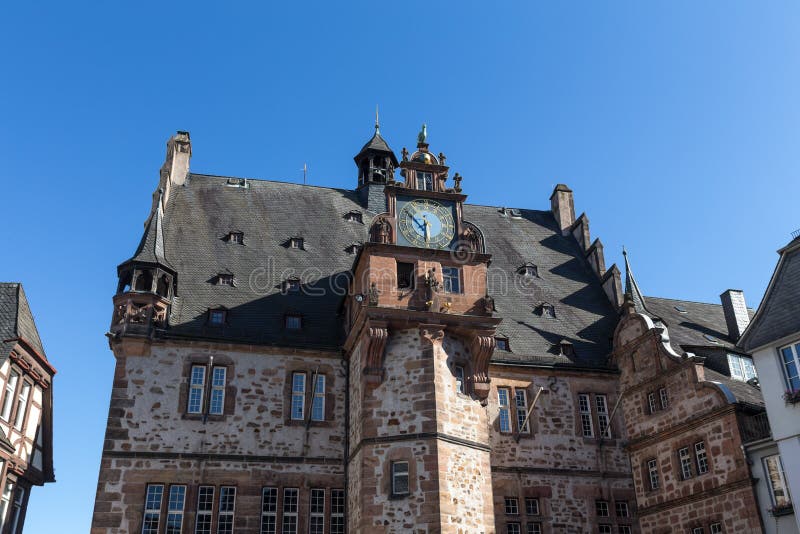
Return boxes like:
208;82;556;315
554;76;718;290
0;282;56;534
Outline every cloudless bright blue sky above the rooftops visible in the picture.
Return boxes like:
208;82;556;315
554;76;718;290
0;0;800;533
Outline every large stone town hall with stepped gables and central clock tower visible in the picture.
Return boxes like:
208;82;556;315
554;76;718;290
92;125;776;534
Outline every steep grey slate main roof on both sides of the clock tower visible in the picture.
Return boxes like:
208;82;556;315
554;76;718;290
150;174;617;367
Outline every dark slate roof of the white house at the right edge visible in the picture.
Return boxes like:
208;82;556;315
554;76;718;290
739;237;800;352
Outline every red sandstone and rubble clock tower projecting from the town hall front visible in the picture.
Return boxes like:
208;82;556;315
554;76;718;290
345;125;500;533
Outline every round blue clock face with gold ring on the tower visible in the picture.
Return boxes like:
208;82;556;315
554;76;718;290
397;199;455;248
